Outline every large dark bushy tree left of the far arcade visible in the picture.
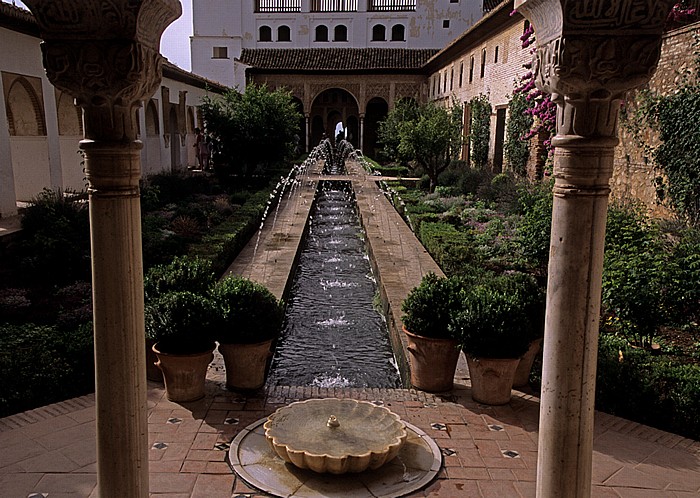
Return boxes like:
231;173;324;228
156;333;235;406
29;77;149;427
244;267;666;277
199;84;301;174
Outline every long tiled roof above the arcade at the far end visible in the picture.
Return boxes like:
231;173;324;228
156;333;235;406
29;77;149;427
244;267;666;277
238;48;438;71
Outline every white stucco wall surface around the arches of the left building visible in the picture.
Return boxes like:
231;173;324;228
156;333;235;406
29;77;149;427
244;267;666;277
0;20;223;217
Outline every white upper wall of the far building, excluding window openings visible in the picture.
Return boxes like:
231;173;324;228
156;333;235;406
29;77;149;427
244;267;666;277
190;0;482;89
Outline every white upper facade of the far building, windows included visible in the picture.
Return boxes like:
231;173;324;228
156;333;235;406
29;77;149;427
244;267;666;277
191;0;483;89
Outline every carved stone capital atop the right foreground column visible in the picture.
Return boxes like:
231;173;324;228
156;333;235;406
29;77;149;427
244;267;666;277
515;0;675;140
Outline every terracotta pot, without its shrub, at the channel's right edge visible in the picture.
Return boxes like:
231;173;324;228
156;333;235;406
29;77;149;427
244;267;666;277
403;328;460;392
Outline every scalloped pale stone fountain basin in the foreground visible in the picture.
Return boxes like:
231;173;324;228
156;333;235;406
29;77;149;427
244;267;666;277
263;398;407;474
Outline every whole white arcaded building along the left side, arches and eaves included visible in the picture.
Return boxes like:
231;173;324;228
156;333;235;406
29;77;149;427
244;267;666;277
0;3;224;218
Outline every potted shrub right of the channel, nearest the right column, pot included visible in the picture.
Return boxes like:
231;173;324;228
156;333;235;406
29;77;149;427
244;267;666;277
450;275;541;405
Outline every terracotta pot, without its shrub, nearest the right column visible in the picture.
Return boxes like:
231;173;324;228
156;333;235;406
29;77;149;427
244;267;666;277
466;355;520;405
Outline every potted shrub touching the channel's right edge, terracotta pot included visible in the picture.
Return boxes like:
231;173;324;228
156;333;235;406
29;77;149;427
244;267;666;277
401;273;468;392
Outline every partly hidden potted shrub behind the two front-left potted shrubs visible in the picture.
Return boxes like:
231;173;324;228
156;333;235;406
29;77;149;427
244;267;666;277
143;256;216;382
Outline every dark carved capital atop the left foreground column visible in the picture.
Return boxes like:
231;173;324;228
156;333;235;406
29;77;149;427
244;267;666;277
25;0;182;141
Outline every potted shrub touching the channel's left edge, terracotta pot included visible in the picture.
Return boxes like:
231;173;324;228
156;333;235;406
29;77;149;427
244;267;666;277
212;275;284;390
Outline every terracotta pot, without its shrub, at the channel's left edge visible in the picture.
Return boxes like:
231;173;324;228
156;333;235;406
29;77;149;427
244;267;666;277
219;339;272;391
